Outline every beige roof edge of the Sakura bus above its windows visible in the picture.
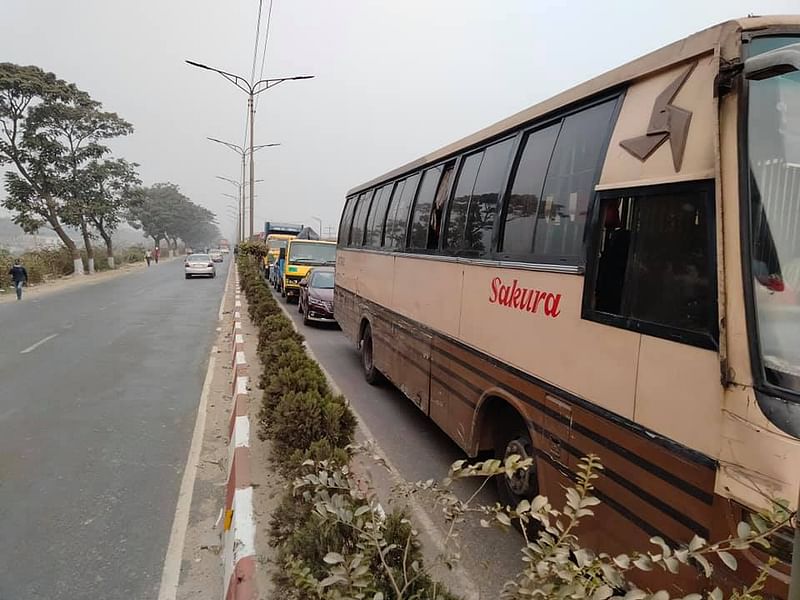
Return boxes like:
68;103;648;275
347;15;800;196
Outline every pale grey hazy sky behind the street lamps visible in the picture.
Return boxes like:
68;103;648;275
0;0;800;241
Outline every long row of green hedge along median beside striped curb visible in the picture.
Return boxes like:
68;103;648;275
238;243;453;600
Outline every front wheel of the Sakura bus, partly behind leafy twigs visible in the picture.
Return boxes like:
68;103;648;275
494;418;539;508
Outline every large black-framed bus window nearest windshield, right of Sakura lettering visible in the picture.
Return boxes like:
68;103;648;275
584;182;717;347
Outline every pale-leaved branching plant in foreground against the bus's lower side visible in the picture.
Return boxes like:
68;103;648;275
402;455;794;600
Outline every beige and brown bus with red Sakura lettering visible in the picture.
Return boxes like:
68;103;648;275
334;16;800;596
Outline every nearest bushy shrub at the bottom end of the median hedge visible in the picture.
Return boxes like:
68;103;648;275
280;461;454;600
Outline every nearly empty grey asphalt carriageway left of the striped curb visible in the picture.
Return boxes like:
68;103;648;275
0;259;228;600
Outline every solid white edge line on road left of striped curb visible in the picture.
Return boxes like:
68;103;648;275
158;260;231;600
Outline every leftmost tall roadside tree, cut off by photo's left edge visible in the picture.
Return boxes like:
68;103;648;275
0;63;88;273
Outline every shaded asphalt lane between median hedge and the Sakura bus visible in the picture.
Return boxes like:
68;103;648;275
275;284;524;598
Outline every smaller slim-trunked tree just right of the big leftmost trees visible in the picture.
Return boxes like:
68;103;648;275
84;159;141;269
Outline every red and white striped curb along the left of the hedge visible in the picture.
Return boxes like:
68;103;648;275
222;273;258;600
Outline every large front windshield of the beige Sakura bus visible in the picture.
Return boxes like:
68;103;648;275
748;36;800;394
